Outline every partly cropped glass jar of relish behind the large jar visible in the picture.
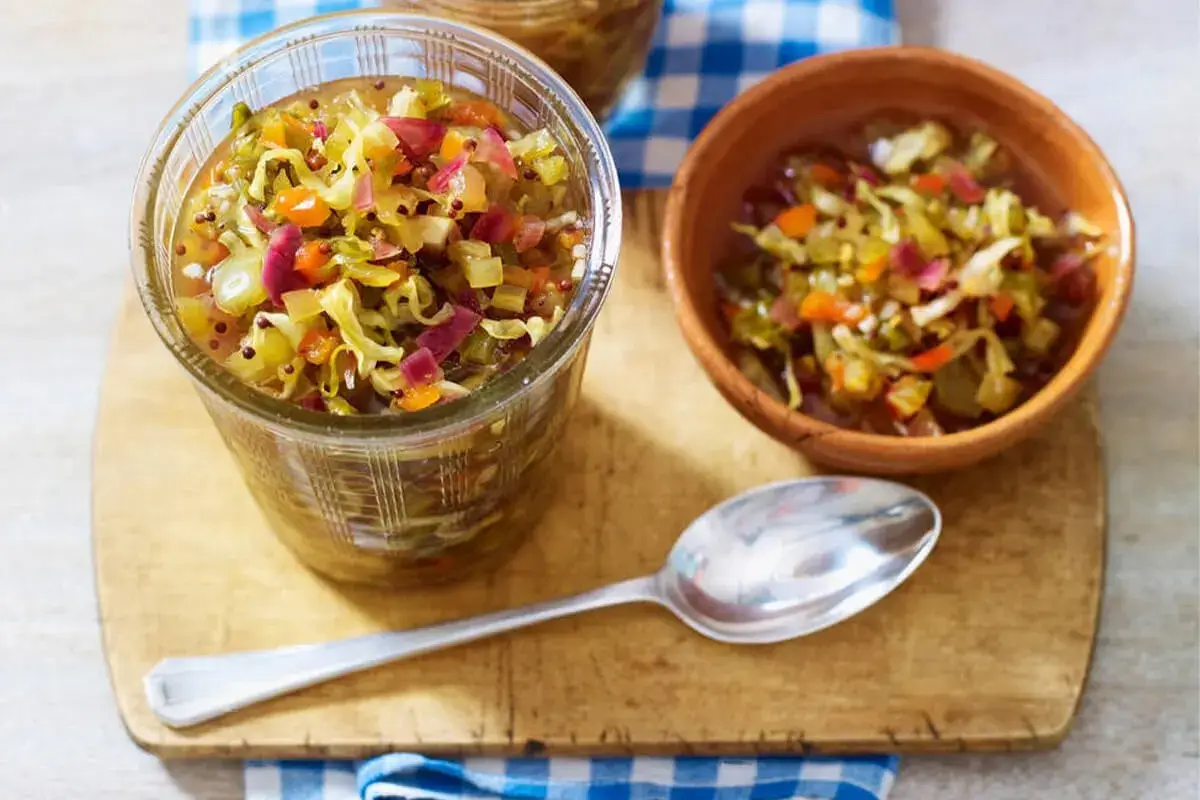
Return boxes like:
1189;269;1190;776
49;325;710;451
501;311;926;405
388;0;662;119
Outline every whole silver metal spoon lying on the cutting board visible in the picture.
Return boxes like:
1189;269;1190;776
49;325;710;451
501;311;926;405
145;476;942;728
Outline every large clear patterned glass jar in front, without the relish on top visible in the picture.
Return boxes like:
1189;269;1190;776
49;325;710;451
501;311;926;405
131;11;620;585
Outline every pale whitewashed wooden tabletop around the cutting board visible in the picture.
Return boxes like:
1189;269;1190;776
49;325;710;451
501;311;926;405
0;0;1200;800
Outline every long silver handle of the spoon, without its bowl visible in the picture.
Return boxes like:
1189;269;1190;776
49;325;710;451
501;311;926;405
143;576;662;728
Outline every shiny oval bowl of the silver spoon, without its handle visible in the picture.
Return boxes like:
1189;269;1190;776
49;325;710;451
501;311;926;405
659;476;942;644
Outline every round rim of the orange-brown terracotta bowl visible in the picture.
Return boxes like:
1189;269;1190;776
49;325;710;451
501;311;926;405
661;46;1135;462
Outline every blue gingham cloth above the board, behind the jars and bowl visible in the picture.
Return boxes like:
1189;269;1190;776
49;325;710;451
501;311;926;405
191;0;898;190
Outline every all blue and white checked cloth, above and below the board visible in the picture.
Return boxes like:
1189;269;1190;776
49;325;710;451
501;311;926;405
191;0;896;800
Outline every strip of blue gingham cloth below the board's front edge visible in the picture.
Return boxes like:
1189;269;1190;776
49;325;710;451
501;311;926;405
246;753;896;800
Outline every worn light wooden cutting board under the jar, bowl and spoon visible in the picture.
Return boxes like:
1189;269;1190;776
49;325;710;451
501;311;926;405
94;190;1105;758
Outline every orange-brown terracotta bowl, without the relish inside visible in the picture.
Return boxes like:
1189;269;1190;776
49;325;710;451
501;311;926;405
662;47;1134;474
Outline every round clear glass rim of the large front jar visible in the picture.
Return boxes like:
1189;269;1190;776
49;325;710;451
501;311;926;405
130;10;622;440
